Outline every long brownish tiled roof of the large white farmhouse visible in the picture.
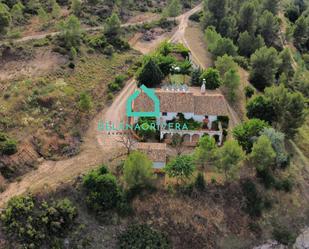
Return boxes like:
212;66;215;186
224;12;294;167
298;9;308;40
133;87;229;116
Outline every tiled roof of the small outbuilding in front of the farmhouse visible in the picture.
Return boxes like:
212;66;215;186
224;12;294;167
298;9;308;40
135;143;166;163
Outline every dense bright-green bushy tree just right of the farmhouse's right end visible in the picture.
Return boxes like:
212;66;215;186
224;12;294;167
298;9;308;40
233;119;269;153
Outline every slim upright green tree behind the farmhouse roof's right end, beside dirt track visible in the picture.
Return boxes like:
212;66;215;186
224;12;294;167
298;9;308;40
223;69;240;102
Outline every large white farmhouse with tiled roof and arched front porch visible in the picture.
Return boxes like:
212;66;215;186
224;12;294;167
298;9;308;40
132;85;229;146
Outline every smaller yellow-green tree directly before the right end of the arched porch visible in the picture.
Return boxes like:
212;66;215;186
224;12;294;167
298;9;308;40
193;136;217;167
